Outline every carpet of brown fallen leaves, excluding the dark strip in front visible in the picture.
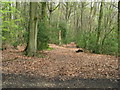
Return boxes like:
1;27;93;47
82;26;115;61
2;44;118;80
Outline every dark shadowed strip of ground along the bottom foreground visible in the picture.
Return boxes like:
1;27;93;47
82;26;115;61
2;74;118;88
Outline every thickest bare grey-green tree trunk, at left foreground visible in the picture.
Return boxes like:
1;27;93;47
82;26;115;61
27;2;38;56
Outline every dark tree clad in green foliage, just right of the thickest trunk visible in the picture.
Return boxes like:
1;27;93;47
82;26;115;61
37;2;49;50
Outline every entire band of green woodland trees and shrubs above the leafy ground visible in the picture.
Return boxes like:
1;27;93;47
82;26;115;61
0;2;118;56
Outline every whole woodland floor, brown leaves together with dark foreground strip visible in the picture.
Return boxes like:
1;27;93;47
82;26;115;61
2;44;119;88
